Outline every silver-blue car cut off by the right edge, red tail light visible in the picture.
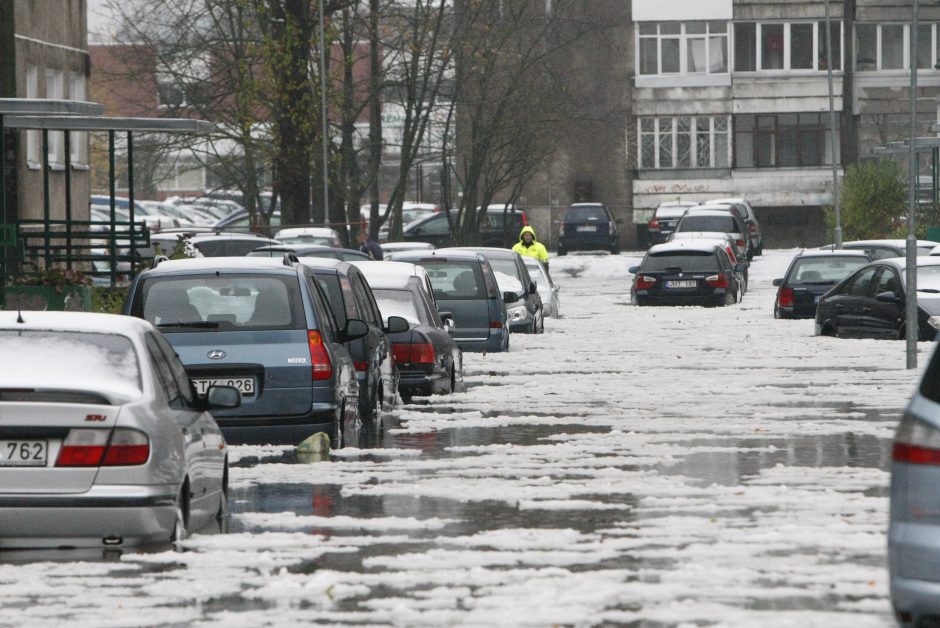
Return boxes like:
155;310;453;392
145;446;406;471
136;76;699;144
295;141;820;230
888;340;940;628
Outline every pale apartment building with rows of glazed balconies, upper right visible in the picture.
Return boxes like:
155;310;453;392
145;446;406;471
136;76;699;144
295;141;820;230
627;0;940;246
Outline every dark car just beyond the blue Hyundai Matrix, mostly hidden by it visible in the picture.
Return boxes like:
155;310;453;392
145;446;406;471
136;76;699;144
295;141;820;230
300;257;408;421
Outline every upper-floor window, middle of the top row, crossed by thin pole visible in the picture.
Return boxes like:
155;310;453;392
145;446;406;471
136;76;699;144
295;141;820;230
734;21;842;72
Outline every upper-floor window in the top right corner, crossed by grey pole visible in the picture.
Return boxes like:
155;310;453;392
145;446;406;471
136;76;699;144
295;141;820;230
855;22;940;72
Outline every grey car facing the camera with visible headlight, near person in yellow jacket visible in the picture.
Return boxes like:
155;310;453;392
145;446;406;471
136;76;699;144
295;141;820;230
444;247;545;334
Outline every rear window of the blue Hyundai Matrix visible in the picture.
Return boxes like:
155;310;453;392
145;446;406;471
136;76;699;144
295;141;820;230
135;273;305;333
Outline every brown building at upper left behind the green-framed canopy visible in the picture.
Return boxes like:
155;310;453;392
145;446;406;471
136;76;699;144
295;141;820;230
0;0;89;223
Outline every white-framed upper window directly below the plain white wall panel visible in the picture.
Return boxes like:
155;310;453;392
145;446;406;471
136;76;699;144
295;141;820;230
637;22;728;75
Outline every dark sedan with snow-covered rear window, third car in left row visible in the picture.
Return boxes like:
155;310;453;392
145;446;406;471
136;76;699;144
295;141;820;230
354;262;463;399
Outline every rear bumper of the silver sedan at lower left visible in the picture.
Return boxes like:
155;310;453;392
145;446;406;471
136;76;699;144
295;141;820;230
0;485;178;550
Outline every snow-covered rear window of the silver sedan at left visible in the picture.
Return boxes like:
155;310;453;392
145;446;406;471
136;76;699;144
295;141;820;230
0;329;141;391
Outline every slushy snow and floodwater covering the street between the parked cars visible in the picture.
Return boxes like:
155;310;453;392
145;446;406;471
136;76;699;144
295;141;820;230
0;251;916;628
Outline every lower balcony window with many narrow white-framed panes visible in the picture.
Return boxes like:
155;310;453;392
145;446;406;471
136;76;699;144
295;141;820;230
639;116;730;169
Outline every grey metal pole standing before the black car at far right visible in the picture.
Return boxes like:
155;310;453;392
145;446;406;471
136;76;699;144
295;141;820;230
904;0;920;369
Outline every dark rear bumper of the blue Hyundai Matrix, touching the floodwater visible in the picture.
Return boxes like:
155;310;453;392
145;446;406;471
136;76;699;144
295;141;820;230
216;403;339;445
